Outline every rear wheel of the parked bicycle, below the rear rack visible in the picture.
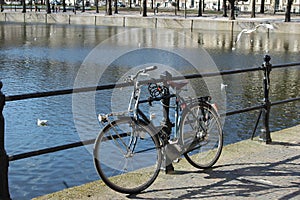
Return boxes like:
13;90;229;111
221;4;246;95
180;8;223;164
181;102;223;169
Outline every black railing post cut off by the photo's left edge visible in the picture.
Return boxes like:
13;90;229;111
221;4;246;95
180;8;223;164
0;81;10;200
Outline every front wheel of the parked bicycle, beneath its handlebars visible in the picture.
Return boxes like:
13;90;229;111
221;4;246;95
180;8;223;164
94;117;162;194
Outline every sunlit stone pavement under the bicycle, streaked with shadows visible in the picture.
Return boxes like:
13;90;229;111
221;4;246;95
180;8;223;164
36;125;300;200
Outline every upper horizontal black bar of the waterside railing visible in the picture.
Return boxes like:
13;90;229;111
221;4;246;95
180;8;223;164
5;63;300;101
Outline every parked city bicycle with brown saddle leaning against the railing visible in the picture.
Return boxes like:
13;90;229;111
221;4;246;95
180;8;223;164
93;66;223;194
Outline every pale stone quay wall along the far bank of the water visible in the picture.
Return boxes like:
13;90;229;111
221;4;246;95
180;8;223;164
0;12;300;34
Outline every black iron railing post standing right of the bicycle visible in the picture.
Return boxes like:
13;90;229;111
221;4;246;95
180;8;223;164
260;55;272;144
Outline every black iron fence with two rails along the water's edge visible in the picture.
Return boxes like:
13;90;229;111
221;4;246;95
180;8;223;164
0;55;300;199
